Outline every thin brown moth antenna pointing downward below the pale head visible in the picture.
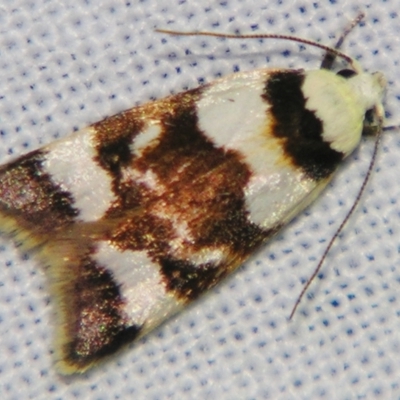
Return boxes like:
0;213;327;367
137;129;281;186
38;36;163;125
289;123;382;320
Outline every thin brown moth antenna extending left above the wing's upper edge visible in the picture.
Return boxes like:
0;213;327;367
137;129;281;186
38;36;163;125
155;27;364;73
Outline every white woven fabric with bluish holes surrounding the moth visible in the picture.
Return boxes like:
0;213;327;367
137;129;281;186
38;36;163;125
0;0;400;400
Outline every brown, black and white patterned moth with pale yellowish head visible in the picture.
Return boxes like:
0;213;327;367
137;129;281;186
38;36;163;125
0;13;386;374
